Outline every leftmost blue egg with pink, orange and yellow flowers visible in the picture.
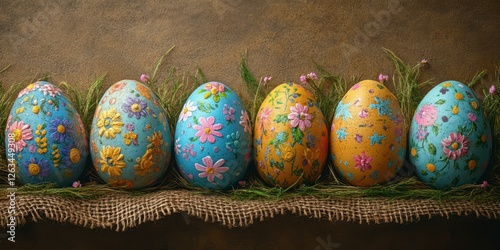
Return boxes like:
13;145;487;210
5;81;89;187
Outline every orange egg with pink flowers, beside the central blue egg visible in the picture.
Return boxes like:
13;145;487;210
254;83;328;188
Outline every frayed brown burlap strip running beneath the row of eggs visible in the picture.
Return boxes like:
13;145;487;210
0;190;500;231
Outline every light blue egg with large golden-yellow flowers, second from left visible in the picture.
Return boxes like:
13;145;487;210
90;80;172;189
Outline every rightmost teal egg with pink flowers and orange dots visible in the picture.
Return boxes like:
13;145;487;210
409;81;492;189
